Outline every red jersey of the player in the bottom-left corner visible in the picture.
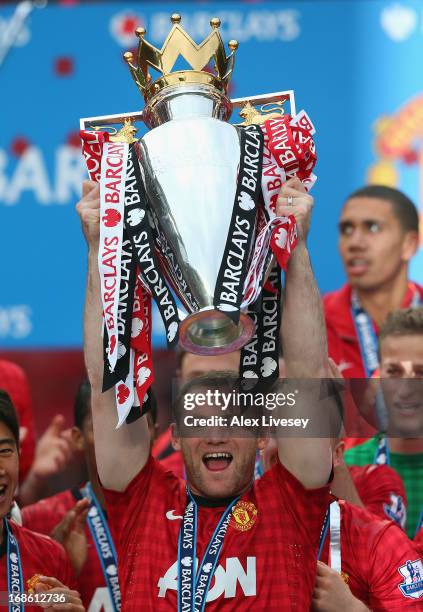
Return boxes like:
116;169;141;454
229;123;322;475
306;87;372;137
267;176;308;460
0;521;73;610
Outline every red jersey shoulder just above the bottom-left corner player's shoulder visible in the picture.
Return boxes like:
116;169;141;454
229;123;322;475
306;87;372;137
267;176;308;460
21;490;76;535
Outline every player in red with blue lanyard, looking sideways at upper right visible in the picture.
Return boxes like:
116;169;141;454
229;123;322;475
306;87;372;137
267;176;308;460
323;185;423;378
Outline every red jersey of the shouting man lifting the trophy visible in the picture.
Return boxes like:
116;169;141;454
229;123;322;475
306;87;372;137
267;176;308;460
105;457;329;612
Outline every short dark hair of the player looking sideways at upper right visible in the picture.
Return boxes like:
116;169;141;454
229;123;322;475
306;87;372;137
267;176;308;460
345;185;419;232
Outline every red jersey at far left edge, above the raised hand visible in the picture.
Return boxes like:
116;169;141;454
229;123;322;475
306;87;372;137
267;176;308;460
0;359;35;482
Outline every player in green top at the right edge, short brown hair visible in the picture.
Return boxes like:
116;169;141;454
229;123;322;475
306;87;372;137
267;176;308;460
345;307;423;538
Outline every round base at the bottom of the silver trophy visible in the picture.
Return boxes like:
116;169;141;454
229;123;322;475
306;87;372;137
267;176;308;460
179;308;255;356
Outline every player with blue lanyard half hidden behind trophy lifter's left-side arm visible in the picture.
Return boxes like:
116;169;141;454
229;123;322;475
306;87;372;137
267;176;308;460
22;381;120;612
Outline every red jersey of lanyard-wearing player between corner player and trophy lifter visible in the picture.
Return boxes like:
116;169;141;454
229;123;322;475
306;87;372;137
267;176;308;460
22;491;113;612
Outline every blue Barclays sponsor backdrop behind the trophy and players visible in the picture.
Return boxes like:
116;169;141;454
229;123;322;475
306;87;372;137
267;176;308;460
0;0;423;348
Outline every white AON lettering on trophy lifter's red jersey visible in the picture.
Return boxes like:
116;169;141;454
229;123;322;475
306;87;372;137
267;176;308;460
157;557;257;602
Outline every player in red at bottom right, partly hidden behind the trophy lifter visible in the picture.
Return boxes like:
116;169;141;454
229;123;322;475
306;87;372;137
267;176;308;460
263;438;423;612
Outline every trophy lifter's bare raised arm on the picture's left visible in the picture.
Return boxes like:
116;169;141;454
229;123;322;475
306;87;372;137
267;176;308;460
76;181;150;491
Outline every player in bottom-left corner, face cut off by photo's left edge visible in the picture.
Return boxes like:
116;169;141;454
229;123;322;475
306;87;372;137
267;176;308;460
0;390;84;612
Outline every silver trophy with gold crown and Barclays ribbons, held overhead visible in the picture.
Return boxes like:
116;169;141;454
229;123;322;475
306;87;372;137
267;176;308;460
81;15;316;423
